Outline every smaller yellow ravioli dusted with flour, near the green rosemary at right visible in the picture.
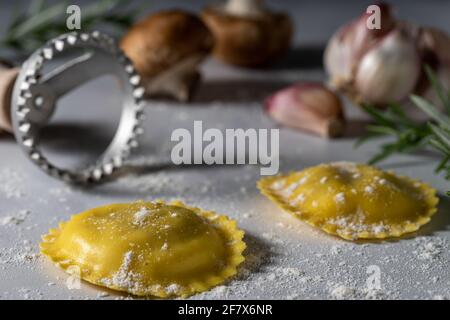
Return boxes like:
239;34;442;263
258;162;439;240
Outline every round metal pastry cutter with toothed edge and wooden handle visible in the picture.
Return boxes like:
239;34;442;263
0;31;144;183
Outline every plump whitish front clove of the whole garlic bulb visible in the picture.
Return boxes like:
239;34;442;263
354;29;421;105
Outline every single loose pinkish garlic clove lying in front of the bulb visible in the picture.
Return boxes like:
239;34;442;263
265;83;344;137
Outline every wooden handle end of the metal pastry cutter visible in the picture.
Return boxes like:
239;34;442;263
0;60;19;134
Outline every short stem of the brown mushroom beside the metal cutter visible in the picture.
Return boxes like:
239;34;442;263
146;54;205;101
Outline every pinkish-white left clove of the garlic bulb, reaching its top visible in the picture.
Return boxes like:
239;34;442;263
324;4;395;88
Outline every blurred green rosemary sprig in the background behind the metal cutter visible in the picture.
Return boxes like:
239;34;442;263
0;0;140;57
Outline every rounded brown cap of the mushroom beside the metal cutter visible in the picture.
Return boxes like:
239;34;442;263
121;10;214;78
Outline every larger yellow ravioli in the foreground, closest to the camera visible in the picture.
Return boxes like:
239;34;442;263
41;201;246;298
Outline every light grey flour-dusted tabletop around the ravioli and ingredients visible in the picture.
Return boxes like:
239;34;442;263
0;1;450;299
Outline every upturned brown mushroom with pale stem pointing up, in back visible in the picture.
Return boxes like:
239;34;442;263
202;0;293;67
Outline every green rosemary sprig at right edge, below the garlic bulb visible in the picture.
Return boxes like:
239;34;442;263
356;67;450;185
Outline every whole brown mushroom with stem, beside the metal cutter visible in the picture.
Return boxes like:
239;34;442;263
121;10;214;101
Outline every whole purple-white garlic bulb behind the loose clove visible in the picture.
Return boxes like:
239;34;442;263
324;5;450;106
